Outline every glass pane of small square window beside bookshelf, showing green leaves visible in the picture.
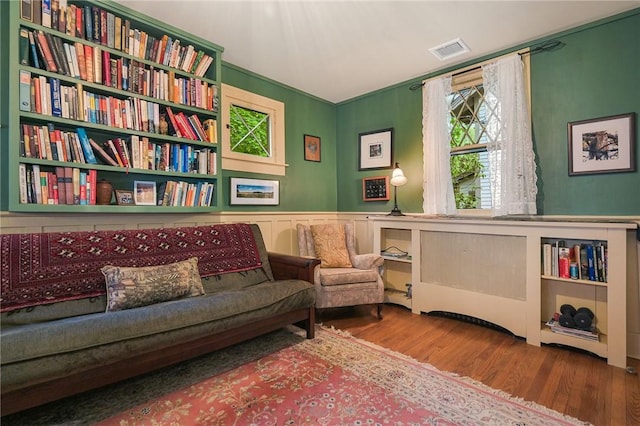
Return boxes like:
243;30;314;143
230;105;271;157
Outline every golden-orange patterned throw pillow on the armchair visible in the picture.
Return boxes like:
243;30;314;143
311;224;351;268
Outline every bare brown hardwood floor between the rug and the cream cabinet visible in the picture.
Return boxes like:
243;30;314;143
321;305;640;426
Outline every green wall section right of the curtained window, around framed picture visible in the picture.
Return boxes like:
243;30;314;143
531;9;640;215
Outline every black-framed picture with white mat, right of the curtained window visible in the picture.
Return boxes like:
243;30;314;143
567;112;636;176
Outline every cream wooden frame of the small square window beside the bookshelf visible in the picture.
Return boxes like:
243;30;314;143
221;84;287;176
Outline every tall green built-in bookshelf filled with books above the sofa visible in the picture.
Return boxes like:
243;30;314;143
7;0;222;213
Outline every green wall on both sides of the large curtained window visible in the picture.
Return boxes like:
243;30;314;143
337;9;640;215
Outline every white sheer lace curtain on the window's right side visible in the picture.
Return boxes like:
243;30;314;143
482;54;538;216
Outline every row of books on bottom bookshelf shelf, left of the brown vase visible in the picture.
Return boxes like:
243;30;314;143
19;164;97;205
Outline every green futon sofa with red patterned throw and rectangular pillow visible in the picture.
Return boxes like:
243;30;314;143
0;224;319;415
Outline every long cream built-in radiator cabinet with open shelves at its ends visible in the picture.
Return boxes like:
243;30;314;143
370;215;640;367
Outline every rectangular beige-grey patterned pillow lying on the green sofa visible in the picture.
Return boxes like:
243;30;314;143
101;257;204;312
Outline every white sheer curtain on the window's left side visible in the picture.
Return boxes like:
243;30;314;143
422;77;456;215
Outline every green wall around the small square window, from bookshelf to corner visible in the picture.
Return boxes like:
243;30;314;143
222;63;338;212
